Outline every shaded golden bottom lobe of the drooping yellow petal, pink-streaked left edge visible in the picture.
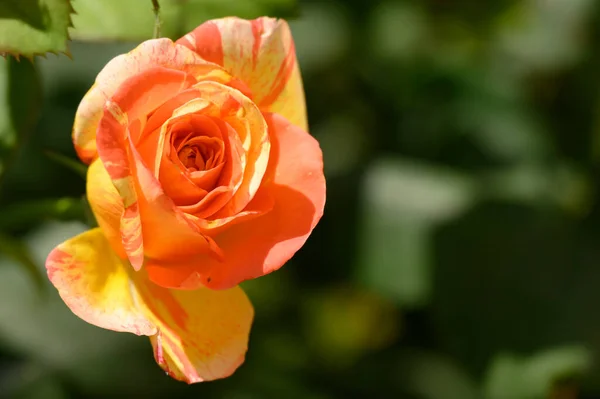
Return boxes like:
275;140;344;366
147;286;254;383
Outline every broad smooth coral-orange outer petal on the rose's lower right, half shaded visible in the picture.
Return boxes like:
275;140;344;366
148;114;325;289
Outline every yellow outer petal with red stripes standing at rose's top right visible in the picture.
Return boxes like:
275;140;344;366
177;17;307;130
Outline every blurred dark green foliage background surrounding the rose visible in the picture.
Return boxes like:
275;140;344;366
0;0;600;399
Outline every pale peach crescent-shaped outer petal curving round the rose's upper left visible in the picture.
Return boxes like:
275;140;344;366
73;39;211;163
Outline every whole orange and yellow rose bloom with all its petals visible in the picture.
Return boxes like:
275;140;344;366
46;17;325;383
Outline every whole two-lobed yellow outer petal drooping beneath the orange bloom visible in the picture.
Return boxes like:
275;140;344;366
46;228;253;383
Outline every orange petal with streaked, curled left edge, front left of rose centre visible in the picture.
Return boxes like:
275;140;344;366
96;97;220;270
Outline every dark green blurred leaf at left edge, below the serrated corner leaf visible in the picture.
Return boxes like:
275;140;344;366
0;55;41;189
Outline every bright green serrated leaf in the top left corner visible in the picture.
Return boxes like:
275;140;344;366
0;0;73;58
